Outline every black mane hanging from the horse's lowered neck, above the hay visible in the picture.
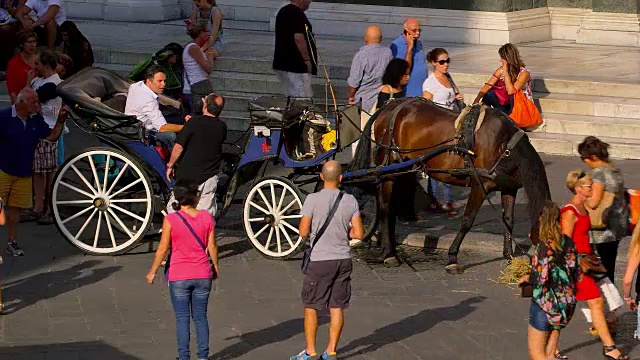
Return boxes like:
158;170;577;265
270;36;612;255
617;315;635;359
516;136;551;231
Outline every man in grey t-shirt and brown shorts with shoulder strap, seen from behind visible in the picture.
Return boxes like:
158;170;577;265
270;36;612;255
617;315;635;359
290;160;364;360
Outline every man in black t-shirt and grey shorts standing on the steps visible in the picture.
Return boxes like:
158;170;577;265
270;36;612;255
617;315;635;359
273;0;318;97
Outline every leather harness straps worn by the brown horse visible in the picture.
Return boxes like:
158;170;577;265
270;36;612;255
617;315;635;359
374;98;525;186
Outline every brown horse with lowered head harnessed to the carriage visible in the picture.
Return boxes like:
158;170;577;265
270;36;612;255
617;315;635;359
351;98;551;272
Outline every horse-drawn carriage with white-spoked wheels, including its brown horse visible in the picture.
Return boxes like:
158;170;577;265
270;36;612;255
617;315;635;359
52;68;550;271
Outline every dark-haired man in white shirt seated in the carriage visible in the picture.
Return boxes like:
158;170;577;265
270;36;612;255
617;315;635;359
124;65;183;151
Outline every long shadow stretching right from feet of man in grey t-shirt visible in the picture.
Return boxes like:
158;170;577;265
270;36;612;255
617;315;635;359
340;296;486;359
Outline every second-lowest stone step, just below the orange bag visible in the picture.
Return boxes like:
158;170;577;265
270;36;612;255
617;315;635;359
535;113;640;139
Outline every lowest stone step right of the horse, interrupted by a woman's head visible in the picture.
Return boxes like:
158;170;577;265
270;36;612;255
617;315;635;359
527;132;640;159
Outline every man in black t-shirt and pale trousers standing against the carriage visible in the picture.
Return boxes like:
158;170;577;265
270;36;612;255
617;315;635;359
167;94;227;216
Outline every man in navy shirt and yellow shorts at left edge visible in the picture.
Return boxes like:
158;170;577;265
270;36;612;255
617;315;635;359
0;88;68;256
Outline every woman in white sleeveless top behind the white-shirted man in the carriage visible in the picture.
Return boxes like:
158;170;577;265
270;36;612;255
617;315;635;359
182;22;213;114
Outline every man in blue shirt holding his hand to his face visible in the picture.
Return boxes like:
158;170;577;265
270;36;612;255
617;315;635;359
391;18;428;97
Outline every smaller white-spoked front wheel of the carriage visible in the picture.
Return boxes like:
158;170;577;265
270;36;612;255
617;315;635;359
244;177;304;260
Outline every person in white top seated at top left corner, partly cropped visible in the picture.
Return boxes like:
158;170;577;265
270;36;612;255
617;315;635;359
15;0;67;49
